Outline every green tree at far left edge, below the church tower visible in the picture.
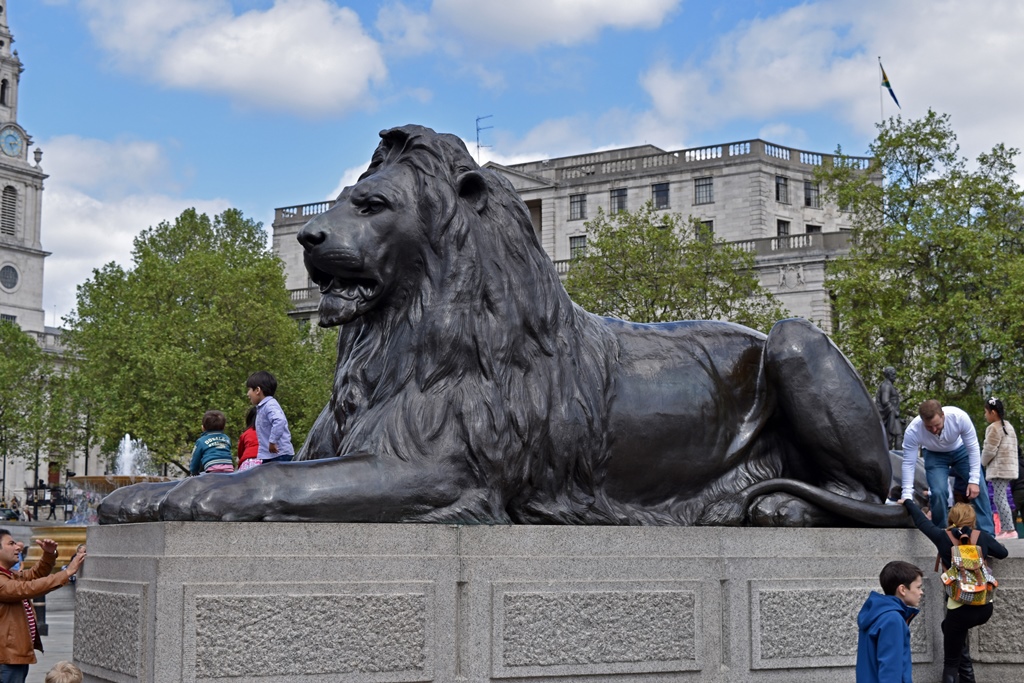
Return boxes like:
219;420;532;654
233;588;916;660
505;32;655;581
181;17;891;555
0;321;43;495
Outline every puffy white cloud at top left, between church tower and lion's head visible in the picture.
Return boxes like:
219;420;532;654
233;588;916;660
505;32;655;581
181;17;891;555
82;0;387;115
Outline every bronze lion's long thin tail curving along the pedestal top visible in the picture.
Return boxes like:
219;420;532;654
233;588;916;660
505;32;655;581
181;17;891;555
697;479;913;528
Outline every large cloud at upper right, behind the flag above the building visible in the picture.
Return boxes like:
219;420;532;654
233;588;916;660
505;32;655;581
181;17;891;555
637;0;1024;155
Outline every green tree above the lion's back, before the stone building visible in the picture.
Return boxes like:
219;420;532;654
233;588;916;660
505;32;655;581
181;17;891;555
565;202;786;332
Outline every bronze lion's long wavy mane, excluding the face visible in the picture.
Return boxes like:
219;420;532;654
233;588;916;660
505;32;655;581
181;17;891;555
301;126;618;523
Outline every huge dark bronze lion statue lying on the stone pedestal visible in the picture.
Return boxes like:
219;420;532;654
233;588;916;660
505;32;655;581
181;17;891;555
99;126;906;526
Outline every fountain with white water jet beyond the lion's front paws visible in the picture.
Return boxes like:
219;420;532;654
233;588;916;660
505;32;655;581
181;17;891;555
26;434;171;570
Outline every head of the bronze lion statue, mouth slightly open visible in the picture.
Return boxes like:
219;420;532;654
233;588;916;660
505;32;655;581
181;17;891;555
298;126;534;327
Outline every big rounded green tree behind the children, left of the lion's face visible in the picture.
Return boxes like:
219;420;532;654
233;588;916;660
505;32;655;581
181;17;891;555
66;209;330;469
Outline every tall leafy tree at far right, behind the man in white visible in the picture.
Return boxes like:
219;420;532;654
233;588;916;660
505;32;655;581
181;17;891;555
819;111;1024;415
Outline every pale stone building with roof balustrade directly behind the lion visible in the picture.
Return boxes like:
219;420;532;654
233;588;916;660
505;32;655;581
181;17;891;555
273;140;868;332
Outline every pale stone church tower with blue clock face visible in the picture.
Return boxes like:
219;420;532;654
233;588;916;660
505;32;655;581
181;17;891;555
0;0;49;341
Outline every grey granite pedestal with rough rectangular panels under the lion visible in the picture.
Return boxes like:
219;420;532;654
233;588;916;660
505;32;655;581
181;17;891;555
75;522;1024;683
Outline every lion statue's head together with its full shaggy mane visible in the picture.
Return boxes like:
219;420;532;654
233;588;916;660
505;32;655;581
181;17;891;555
299;126;613;520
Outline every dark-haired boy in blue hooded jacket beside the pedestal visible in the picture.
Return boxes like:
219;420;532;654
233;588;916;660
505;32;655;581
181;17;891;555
857;560;925;683
